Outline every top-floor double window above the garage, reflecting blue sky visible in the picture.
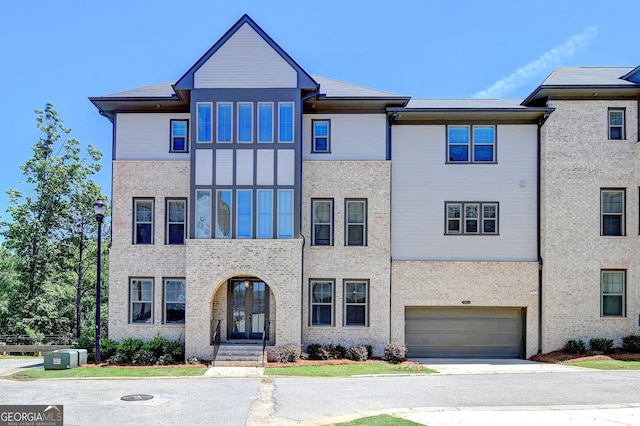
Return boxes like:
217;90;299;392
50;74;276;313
447;126;496;163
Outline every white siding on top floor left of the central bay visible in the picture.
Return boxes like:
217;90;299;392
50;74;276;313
114;113;189;161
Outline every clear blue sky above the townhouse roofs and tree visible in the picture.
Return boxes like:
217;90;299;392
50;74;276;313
0;0;640;219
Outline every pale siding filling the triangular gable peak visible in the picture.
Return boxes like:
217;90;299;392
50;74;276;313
194;24;298;89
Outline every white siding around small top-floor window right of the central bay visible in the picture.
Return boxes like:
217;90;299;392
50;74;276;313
302;114;387;161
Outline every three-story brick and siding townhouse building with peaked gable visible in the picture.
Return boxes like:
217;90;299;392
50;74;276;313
91;15;640;359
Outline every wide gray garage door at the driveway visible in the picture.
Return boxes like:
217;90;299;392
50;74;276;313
405;307;525;358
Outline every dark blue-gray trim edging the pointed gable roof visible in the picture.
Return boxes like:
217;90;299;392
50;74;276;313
175;14;317;90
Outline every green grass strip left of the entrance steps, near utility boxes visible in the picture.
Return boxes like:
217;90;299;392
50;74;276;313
9;366;207;380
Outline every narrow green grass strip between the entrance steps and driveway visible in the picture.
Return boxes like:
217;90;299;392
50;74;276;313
264;363;436;377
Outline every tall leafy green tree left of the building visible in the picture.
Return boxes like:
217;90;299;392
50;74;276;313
0;103;102;333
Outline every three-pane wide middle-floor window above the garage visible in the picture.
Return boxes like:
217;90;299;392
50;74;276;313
445;202;498;235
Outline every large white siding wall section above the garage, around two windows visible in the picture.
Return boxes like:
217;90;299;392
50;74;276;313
391;125;537;261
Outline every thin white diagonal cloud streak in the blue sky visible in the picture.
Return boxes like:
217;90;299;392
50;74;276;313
473;27;598;98
